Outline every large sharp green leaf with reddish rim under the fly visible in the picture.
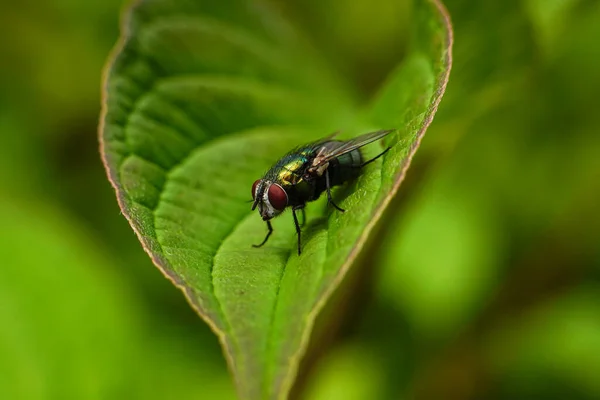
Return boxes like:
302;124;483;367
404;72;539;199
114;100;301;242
101;0;452;399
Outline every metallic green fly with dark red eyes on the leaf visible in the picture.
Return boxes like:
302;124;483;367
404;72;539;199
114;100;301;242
252;130;393;254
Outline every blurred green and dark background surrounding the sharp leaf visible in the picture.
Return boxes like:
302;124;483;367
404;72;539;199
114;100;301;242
0;0;600;399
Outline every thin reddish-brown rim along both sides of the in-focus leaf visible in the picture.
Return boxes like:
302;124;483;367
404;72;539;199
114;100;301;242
98;0;454;399
